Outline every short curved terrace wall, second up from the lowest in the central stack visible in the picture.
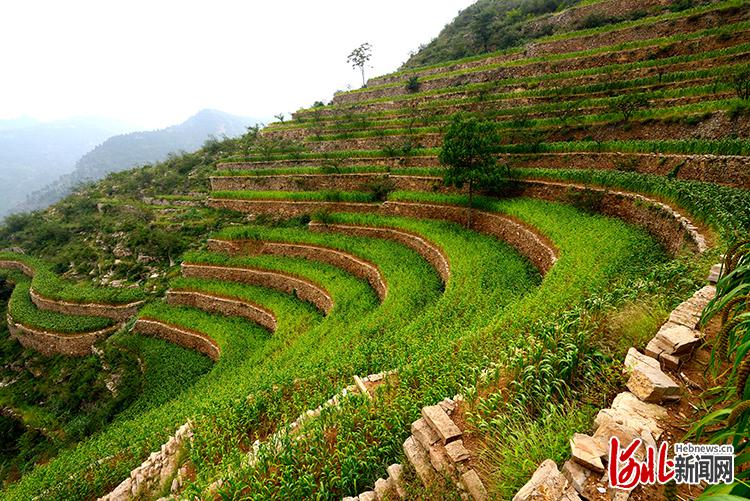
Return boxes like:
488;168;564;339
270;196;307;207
167;289;276;332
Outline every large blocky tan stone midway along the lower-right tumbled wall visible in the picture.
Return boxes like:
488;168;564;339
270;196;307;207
625;348;680;403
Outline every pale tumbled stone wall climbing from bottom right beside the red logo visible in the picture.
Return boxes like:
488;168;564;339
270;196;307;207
513;286;716;501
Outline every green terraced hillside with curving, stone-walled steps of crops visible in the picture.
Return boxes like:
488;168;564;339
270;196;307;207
0;0;750;499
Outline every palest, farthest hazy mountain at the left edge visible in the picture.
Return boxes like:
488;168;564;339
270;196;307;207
0;117;128;216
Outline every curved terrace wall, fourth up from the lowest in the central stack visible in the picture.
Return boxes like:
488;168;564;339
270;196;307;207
208;239;388;302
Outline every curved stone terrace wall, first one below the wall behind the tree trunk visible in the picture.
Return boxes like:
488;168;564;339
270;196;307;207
309;221;451;283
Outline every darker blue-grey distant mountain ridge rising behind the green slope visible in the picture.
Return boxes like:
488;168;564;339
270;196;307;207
14;110;261;211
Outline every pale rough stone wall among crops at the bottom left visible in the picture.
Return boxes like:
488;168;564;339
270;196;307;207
98;422;193;501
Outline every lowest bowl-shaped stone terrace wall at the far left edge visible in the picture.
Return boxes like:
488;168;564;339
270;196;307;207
8;313;120;357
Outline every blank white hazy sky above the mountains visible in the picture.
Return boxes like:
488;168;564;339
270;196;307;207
0;0;473;128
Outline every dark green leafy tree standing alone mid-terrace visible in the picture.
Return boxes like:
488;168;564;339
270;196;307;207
438;115;500;227
